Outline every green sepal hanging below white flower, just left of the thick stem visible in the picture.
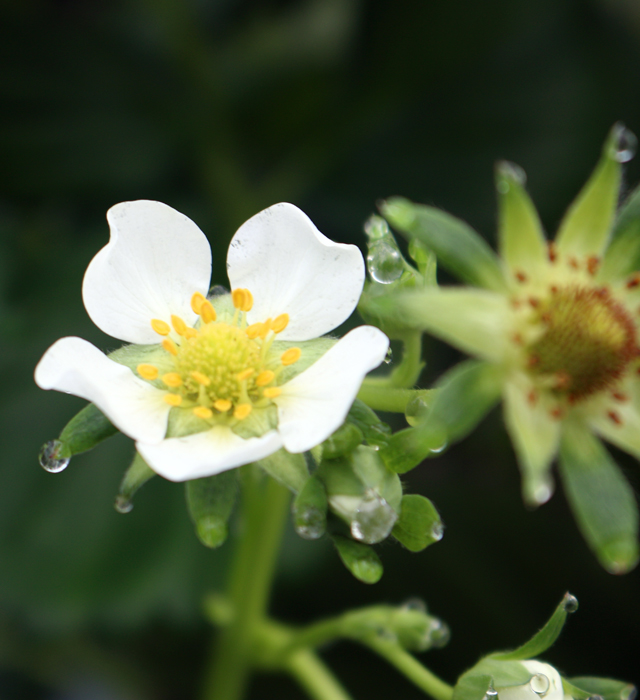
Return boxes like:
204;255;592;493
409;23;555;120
185;469;238;549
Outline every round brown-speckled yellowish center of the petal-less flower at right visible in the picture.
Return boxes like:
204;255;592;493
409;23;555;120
527;286;638;402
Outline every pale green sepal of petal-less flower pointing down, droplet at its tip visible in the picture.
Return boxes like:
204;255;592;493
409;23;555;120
503;380;560;506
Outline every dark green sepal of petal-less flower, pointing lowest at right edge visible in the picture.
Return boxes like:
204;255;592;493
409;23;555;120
560;422;638;574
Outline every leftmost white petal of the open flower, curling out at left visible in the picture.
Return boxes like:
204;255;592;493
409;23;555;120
35;338;170;442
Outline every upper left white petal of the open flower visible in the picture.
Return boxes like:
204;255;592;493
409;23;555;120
82;200;211;344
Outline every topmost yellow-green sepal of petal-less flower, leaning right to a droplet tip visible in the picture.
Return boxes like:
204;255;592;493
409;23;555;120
556;124;624;257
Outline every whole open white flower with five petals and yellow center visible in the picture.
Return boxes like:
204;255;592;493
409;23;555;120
35;201;388;481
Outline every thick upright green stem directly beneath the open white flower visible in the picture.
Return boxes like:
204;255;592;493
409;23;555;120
202;465;289;700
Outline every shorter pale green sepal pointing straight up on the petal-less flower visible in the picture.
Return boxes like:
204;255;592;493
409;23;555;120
496;162;548;277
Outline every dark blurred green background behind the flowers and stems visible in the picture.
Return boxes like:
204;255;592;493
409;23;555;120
0;0;640;700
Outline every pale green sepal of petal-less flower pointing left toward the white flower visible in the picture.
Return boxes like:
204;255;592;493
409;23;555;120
371;287;513;363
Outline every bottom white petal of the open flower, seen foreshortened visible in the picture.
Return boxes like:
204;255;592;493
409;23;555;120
136;425;282;481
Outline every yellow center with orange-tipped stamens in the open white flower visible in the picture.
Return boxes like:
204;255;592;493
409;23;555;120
137;289;301;422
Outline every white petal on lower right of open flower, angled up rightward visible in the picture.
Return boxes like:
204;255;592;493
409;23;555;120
274;326;389;453
